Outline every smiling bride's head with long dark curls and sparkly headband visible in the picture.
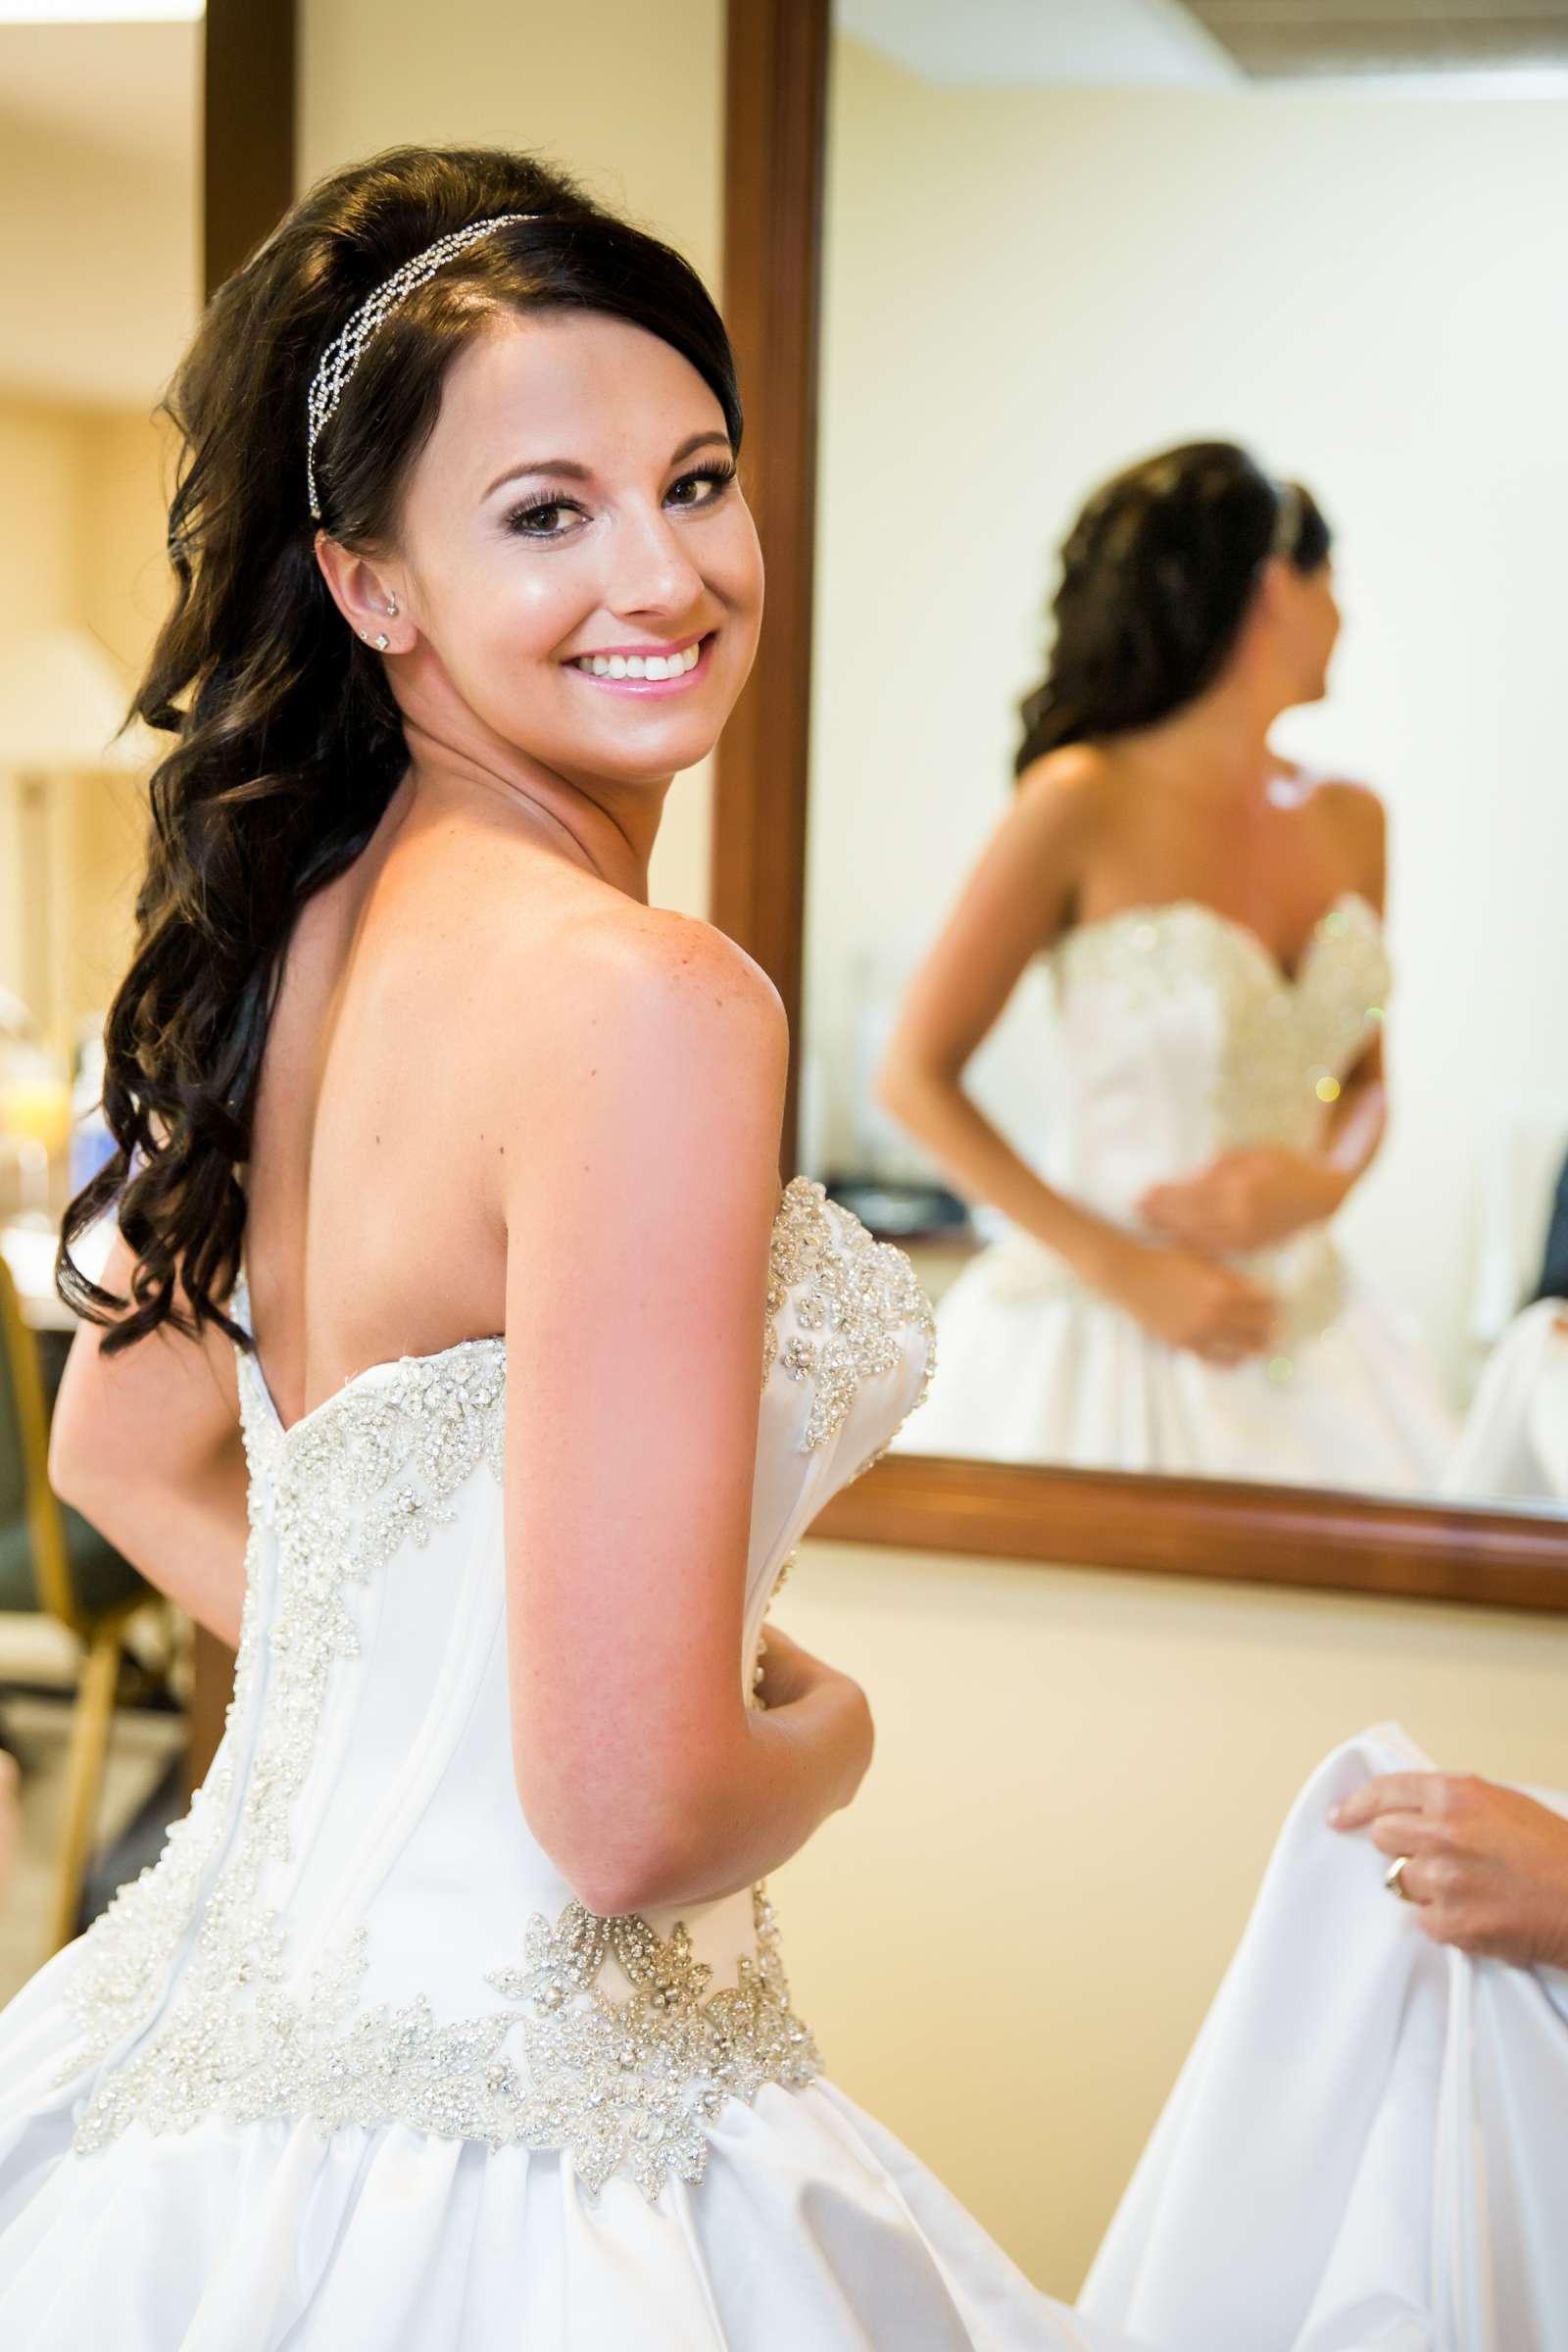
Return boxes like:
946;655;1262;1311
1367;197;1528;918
61;151;761;1352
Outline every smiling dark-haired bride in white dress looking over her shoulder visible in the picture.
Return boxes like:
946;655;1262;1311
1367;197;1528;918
0;148;1142;2352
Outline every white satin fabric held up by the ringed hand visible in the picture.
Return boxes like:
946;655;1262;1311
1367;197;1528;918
1081;1724;1568;2352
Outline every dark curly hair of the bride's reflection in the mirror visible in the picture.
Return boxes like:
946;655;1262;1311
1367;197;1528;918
1013;442;1331;776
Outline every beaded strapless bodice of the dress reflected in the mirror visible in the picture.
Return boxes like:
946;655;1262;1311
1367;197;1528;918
992;892;1392;1339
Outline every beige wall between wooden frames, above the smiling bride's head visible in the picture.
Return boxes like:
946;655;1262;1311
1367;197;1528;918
299;0;724;912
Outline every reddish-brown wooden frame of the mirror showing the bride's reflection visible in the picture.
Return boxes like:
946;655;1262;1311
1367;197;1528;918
710;0;1568;1609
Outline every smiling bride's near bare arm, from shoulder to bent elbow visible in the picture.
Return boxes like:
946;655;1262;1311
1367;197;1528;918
499;910;870;1915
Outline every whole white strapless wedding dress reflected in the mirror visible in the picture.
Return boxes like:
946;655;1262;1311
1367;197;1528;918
898;894;1455;1492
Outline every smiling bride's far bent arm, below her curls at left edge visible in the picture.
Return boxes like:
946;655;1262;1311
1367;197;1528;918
49;1235;247;1648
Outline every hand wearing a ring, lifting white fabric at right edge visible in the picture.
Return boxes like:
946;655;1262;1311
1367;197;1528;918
1328;1771;1568;1969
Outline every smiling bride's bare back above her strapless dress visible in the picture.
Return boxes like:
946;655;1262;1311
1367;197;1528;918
244;778;639;1423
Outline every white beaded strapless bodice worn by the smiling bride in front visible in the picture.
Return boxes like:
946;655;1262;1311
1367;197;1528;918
61;1178;933;2197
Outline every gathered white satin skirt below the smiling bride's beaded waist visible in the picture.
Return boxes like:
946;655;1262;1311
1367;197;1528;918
0;1945;1142;2352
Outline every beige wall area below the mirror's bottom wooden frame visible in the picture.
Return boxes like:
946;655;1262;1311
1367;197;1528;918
771;1543;1568;2295
